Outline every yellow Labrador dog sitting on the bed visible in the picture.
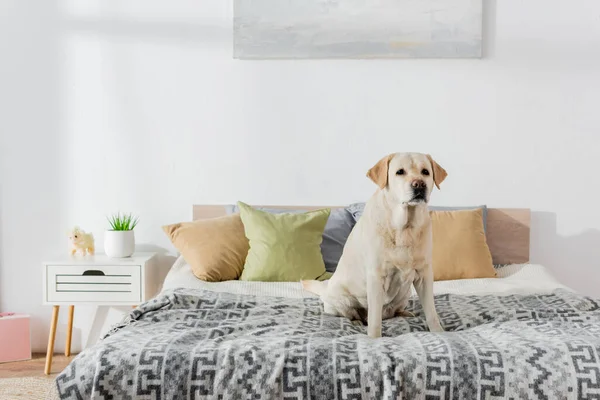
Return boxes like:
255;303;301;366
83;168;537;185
302;153;447;338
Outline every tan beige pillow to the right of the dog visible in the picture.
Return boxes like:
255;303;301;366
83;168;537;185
429;208;496;281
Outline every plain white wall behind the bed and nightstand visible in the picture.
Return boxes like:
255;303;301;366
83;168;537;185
0;0;600;350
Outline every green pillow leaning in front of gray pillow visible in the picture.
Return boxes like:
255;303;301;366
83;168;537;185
238;201;331;282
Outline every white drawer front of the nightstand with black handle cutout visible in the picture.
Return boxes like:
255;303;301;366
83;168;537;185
46;265;141;303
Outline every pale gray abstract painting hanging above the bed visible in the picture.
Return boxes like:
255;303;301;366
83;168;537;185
234;0;483;59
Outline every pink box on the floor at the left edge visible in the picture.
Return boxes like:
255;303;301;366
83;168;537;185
0;313;31;363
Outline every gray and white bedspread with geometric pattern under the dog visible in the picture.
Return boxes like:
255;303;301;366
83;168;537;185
56;289;600;400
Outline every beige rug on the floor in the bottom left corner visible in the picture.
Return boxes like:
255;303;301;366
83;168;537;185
0;377;58;400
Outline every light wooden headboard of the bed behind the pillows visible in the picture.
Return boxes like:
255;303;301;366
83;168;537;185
193;205;531;264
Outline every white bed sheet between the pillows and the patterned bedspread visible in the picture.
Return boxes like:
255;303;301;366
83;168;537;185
162;257;572;298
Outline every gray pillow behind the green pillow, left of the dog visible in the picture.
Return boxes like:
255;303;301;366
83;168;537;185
225;205;356;273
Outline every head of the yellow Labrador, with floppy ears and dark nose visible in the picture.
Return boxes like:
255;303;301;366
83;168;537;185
367;153;448;205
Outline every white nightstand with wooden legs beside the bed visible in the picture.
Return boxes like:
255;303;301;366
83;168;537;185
43;253;161;375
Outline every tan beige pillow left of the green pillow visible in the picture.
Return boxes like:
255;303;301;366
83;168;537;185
163;214;250;282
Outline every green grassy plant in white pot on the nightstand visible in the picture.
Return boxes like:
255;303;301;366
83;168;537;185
104;212;138;258
